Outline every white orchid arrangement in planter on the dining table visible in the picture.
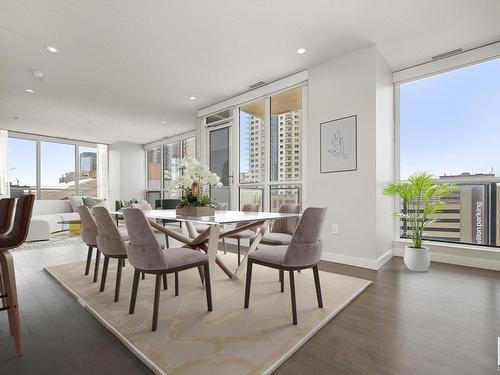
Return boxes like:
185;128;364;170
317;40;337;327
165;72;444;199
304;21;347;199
172;157;222;216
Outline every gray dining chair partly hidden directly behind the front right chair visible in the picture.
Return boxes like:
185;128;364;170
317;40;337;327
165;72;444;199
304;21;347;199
260;204;301;246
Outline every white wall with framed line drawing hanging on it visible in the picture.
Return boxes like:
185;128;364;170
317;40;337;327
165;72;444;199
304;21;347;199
307;46;394;269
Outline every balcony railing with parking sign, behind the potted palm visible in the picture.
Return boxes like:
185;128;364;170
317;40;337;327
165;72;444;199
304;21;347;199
400;178;500;246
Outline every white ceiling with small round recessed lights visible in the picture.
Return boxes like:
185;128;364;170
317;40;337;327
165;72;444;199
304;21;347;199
0;0;500;143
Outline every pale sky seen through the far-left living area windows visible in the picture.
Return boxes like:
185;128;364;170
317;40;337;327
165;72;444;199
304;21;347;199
7;138;96;187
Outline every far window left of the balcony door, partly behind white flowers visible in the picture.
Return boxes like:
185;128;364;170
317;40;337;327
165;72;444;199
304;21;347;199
145;137;196;207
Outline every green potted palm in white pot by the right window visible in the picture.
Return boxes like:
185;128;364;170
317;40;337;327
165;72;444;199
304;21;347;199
384;172;457;272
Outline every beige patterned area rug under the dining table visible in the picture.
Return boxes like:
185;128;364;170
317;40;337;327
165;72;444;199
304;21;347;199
46;253;370;375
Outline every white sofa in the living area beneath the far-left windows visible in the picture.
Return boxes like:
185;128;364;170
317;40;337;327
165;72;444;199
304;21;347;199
26;200;80;241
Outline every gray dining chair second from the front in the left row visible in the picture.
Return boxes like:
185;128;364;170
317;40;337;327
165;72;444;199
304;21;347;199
92;207;142;302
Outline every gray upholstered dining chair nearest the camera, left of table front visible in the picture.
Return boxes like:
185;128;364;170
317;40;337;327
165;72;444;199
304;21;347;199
123;208;212;331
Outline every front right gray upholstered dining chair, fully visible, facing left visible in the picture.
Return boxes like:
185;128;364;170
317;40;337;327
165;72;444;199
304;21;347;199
245;207;326;324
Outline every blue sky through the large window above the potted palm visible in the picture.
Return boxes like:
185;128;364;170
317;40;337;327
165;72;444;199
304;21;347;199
400;59;500;179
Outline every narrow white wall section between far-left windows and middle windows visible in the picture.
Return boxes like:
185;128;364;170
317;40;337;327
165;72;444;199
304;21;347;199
108;142;146;208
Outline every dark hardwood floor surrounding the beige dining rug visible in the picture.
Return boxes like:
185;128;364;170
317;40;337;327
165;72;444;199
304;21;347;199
0;247;500;375
